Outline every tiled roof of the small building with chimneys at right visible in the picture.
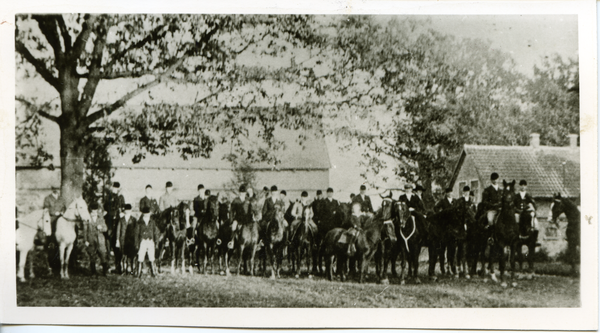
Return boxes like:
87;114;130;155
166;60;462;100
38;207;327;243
458;145;581;197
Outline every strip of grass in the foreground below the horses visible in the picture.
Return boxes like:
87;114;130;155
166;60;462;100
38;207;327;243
17;249;580;308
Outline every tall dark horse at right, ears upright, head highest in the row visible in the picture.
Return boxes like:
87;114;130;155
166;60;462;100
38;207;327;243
488;180;519;287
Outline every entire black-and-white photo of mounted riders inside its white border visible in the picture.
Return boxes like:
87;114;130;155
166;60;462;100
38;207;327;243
2;0;598;328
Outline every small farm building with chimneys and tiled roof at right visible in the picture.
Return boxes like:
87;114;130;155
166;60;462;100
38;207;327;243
450;133;580;256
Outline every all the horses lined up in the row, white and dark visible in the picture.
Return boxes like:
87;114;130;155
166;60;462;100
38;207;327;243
17;181;579;284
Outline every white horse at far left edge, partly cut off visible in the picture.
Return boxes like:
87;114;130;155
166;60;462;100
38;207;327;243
15;209;52;282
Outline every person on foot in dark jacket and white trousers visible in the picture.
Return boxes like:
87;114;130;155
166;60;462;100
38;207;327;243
134;207;159;278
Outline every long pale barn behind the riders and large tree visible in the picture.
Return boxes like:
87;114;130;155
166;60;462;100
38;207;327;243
16;131;331;213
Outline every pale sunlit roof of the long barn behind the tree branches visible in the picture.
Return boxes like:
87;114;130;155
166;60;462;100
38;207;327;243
111;129;331;170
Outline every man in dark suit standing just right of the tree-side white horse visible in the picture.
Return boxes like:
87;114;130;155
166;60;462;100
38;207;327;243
83;202;108;276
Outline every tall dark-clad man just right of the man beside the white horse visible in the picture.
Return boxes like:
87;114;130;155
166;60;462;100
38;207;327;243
104;182;125;274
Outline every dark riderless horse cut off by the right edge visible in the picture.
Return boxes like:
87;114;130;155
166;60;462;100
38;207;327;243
549;193;581;274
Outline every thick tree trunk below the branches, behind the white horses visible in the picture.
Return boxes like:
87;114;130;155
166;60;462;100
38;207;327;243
60;126;86;206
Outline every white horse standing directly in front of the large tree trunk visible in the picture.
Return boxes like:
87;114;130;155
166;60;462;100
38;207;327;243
55;197;91;279
